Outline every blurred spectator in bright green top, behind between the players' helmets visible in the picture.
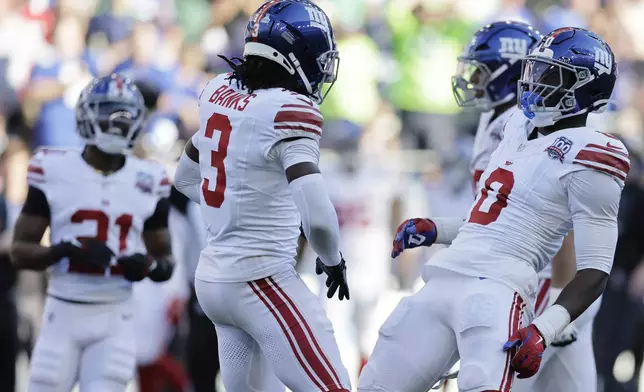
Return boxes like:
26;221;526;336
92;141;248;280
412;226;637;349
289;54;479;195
387;0;472;152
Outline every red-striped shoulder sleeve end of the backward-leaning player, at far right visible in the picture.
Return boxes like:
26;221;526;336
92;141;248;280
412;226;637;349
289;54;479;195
572;130;631;181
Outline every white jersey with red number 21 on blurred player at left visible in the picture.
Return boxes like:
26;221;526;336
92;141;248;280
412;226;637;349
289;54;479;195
27;149;170;302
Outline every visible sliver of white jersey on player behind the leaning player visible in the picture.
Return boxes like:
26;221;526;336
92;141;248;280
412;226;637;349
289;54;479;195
470;106;519;189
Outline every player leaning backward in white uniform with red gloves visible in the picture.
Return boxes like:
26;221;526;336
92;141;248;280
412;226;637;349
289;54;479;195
358;28;629;392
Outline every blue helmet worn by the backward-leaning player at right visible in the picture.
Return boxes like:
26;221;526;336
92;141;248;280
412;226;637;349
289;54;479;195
518;27;617;127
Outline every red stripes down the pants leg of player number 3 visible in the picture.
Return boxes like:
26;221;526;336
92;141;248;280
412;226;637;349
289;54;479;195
249;279;341;391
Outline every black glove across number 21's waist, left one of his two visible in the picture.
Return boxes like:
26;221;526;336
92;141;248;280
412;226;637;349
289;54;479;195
52;239;114;270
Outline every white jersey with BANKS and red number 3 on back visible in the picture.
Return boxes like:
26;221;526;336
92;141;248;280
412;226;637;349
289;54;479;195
192;74;323;282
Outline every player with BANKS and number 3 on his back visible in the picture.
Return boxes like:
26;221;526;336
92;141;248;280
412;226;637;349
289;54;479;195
175;0;351;392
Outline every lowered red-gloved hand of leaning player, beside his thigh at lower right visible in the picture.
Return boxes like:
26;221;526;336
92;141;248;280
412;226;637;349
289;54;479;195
503;324;546;378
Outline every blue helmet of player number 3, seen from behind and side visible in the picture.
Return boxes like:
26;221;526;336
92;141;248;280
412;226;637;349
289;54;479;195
244;0;339;103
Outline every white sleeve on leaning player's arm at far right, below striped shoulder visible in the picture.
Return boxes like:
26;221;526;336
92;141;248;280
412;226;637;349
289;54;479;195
568;170;622;273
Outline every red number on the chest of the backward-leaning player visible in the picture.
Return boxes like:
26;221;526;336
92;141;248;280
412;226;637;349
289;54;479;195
469;168;514;225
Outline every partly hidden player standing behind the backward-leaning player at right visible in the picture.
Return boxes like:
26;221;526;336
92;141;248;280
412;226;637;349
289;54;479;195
452;22;601;392
